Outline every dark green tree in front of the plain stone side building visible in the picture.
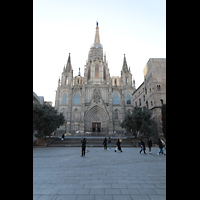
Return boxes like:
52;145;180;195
121;107;156;137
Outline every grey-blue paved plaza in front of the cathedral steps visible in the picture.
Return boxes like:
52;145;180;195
33;144;166;200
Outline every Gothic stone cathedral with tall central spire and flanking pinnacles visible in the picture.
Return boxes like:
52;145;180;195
55;22;166;138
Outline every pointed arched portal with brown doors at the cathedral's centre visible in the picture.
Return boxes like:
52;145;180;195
85;105;109;132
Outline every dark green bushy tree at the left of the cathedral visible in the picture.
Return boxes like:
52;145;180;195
33;102;65;137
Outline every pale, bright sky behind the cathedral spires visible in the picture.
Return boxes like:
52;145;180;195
33;0;166;106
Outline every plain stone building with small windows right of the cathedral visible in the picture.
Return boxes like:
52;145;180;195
132;58;166;136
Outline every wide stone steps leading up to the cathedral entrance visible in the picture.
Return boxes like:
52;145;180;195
47;137;137;148
